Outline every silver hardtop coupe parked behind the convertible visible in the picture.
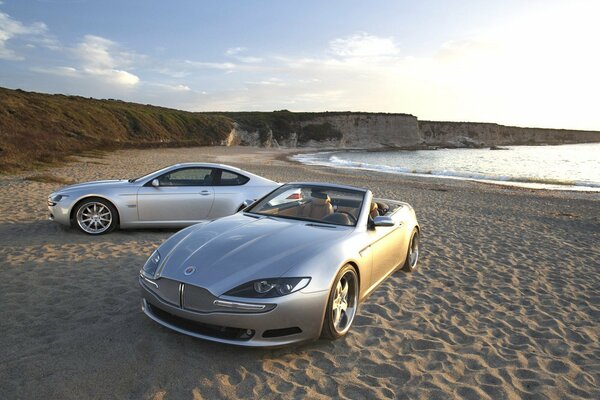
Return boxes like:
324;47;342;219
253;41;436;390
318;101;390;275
48;163;280;235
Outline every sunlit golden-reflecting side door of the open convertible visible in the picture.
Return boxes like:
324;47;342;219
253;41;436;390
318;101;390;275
369;219;403;283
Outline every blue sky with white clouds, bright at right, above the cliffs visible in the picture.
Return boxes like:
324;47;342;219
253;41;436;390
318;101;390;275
0;0;600;130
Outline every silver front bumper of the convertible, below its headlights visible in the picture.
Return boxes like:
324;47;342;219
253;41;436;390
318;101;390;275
139;277;329;347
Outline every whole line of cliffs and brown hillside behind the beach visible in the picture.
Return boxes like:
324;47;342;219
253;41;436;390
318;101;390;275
0;88;600;172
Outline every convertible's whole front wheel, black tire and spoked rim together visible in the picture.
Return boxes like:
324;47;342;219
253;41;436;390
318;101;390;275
321;264;359;340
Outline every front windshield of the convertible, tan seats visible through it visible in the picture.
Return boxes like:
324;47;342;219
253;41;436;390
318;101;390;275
246;184;365;226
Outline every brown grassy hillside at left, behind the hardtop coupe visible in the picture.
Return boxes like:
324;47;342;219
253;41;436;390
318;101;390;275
0;88;233;171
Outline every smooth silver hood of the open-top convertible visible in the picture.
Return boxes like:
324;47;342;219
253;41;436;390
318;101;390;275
159;213;352;295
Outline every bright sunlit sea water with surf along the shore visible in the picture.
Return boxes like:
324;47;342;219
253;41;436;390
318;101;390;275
293;143;600;192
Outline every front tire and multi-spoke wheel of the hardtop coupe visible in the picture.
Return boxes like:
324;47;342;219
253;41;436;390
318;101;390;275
73;198;119;235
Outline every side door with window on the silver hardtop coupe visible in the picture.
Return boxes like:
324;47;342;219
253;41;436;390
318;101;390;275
138;167;214;222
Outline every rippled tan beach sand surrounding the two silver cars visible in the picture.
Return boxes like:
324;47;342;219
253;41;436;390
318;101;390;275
0;148;600;399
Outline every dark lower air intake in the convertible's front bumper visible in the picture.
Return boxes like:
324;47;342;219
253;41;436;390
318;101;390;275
147;303;255;341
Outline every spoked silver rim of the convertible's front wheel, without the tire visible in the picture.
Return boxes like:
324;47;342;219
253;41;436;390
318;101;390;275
331;271;358;334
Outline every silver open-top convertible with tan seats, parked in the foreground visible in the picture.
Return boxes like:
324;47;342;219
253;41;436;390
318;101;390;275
139;183;419;346
